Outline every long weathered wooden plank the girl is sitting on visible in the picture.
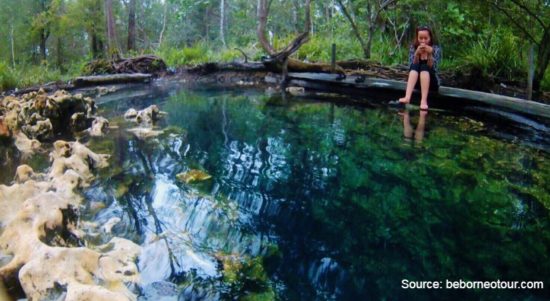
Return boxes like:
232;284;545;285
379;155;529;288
288;72;550;118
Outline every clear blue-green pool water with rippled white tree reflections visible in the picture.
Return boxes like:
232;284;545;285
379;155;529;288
8;85;550;300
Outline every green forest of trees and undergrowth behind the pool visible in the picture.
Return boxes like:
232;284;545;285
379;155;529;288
0;0;550;96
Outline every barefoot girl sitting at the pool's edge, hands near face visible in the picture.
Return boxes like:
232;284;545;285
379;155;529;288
399;26;441;110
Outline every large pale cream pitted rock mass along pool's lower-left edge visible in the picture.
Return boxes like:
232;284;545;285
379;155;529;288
0;141;140;301
